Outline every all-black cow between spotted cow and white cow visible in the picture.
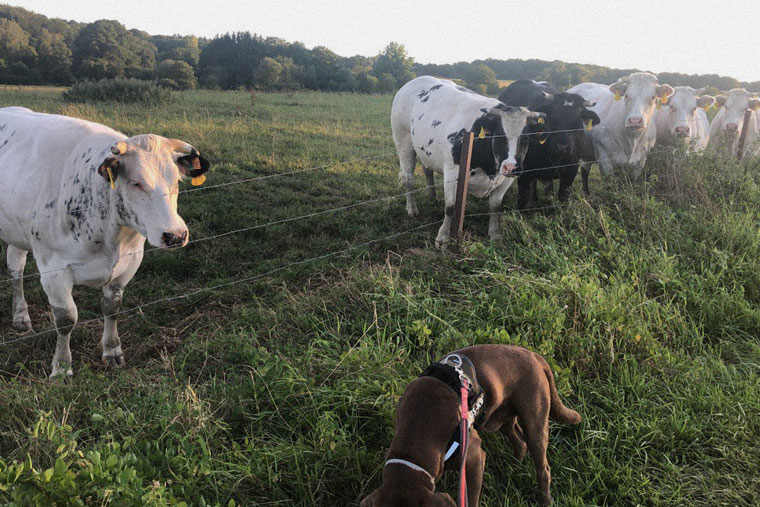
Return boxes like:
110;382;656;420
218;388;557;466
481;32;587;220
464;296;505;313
499;79;599;209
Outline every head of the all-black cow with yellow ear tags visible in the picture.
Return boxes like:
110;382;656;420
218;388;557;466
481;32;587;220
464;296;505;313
531;93;600;164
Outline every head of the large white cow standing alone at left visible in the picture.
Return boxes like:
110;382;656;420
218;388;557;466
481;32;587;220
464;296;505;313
98;134;209;248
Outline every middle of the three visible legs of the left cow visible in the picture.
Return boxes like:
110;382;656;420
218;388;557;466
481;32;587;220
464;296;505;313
40;270;78;379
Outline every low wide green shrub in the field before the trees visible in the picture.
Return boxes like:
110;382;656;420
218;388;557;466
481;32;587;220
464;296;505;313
63;79;174;105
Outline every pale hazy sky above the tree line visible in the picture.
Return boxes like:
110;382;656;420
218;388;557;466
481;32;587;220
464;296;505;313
8;0;760;81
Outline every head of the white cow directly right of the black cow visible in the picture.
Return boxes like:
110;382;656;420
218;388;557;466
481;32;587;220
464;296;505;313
610;72;673;132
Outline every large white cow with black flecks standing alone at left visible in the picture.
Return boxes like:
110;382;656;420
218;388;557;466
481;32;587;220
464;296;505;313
0;108;209;378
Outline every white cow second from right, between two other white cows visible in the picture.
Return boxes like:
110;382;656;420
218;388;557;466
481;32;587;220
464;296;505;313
654;86;715;153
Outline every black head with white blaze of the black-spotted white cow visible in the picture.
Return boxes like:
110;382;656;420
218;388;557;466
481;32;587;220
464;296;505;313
475;104;546;175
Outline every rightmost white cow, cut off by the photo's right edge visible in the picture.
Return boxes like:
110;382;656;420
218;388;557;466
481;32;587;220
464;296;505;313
709;88;760;156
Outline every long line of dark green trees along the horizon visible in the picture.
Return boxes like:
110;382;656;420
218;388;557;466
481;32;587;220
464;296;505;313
0;5;760;95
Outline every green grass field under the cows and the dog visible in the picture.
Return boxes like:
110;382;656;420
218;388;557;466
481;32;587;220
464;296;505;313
0;87;760;507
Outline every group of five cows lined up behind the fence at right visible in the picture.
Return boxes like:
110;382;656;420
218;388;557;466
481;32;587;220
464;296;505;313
391;72;760;246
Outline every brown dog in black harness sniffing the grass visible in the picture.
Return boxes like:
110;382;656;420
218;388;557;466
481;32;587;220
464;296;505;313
361;345;581;507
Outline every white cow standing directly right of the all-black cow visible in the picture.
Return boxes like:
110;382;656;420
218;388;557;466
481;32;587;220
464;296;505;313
567;72;673;178
